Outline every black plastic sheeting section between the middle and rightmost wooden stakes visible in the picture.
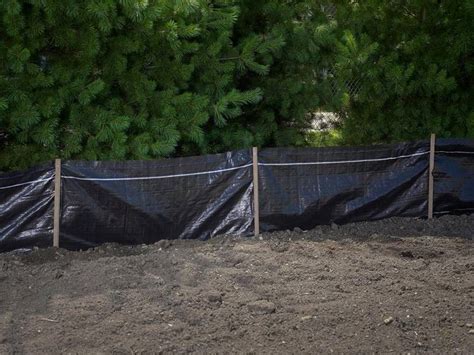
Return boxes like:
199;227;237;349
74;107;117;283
259;141;429;231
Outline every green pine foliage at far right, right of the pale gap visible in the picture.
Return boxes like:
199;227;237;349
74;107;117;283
337;0;474;144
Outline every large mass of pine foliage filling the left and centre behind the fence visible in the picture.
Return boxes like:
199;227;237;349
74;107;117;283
0;0;337;169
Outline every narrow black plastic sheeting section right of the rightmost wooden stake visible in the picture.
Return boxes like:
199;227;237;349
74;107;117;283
433;139;474;214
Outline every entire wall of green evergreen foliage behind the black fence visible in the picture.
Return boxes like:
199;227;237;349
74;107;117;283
4;0;474;170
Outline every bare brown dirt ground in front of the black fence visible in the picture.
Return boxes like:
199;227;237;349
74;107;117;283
0;215;474;354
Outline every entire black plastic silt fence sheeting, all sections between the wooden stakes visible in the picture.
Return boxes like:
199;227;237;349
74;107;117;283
0;139;474;251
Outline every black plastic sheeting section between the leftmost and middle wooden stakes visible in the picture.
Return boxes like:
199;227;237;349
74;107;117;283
60;150;253;249
